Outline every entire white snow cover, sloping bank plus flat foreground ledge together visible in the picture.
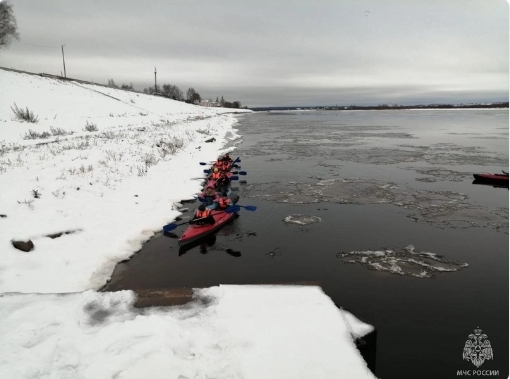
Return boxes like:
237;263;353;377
0;70;373;379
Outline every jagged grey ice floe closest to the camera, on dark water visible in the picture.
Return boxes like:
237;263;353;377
336;245;468;278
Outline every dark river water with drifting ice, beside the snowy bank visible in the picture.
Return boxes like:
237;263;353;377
105;109;509;378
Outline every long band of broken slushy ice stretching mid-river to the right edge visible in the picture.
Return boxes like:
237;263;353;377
243;178;508;233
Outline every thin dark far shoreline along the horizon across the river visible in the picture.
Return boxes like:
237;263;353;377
250;101;509;111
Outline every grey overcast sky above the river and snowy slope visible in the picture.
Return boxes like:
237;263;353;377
0;0;509;107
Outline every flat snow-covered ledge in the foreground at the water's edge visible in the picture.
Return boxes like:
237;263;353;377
0;286;374;379
